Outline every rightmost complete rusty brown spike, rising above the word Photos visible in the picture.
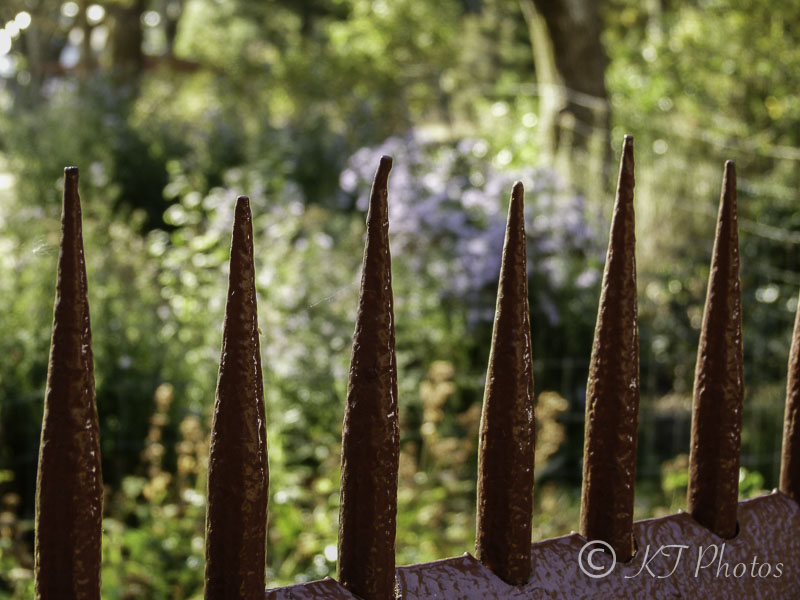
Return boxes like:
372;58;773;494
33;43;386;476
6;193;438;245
687;161;744;538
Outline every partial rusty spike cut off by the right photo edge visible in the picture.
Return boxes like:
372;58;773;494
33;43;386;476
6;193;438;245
780;290;800;502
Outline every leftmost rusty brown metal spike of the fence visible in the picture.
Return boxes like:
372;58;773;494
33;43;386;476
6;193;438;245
35;167;103;600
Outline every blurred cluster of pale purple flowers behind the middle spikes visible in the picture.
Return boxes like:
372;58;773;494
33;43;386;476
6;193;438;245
340;132;600;321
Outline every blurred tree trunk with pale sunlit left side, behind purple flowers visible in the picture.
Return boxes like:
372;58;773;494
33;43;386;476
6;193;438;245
520;0;611;194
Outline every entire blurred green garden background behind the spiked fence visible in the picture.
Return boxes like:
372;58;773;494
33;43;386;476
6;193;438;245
0;0;800;600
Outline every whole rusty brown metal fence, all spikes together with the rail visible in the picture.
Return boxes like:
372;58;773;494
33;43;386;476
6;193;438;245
35;136;800;600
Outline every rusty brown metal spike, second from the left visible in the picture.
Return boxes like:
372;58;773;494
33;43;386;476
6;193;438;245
205;196;269;600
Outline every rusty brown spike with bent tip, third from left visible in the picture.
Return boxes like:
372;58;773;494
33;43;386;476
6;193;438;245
337;156;400;600
